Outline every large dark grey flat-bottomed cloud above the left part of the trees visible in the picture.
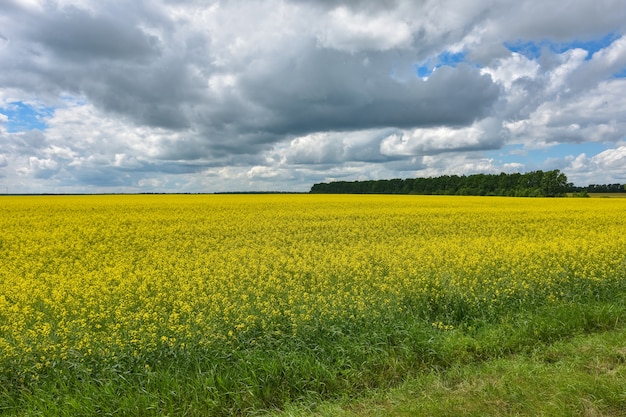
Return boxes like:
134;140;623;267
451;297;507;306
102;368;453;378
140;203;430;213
244;49;499;134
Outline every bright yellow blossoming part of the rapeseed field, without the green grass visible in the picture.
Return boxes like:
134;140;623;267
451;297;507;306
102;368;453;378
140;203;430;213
0;195;626;384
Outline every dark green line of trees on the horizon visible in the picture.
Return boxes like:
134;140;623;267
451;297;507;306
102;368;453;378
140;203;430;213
310;169;626;197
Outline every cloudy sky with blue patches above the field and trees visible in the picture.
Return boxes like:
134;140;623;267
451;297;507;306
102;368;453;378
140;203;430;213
0;0;626;194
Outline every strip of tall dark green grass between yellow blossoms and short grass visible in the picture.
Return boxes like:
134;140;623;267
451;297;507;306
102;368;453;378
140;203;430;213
0;289;626;416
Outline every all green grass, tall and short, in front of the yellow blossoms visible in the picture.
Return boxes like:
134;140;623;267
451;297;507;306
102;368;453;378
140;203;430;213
0;293;626;416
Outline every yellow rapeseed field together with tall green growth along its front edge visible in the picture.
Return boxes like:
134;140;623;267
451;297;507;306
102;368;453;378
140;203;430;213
0;195;626;415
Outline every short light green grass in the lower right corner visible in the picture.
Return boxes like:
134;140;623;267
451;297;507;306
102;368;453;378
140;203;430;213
271;326;626;417
